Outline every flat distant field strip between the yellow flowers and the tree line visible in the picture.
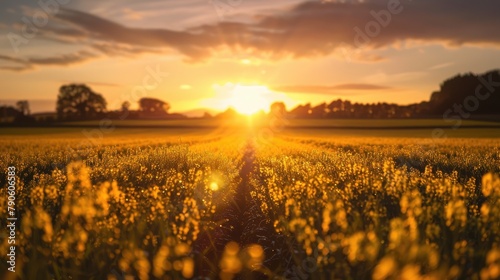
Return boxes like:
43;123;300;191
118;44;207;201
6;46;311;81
0;119;500;138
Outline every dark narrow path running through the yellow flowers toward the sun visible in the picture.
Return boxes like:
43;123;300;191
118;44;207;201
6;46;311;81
193;139;290;279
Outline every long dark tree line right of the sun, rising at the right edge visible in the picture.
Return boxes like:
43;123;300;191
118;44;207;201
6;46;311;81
275;70;500;119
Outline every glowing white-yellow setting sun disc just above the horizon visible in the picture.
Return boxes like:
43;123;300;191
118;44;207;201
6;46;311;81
227;84;271;115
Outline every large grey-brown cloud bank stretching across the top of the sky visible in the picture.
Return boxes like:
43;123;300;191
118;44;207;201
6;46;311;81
0;0;500;70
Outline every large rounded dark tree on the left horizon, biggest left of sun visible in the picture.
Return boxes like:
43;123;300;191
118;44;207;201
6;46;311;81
57;84;106;119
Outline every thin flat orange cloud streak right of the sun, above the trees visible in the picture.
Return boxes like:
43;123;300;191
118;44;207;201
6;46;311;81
271;84;392;94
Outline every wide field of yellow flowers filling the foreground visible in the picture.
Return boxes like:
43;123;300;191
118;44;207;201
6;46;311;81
0;123;500;279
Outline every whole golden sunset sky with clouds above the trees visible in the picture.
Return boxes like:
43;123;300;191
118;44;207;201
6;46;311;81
0;0;500;112
